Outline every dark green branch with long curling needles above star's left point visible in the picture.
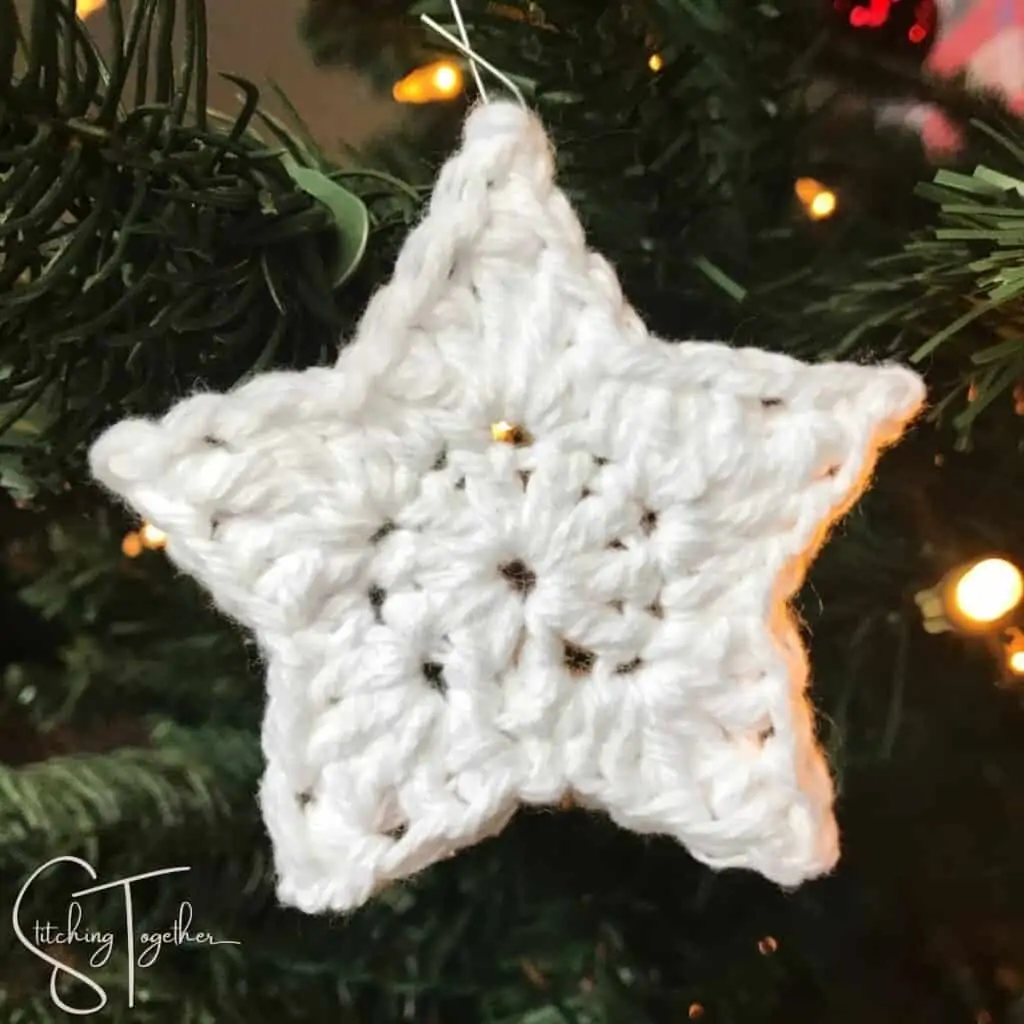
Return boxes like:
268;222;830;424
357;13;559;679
0;0;380;498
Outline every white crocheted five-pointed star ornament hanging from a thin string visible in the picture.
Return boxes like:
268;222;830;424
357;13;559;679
91;102;923;912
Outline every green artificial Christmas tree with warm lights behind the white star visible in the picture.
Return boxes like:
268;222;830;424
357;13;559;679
6;0;1024;1024
